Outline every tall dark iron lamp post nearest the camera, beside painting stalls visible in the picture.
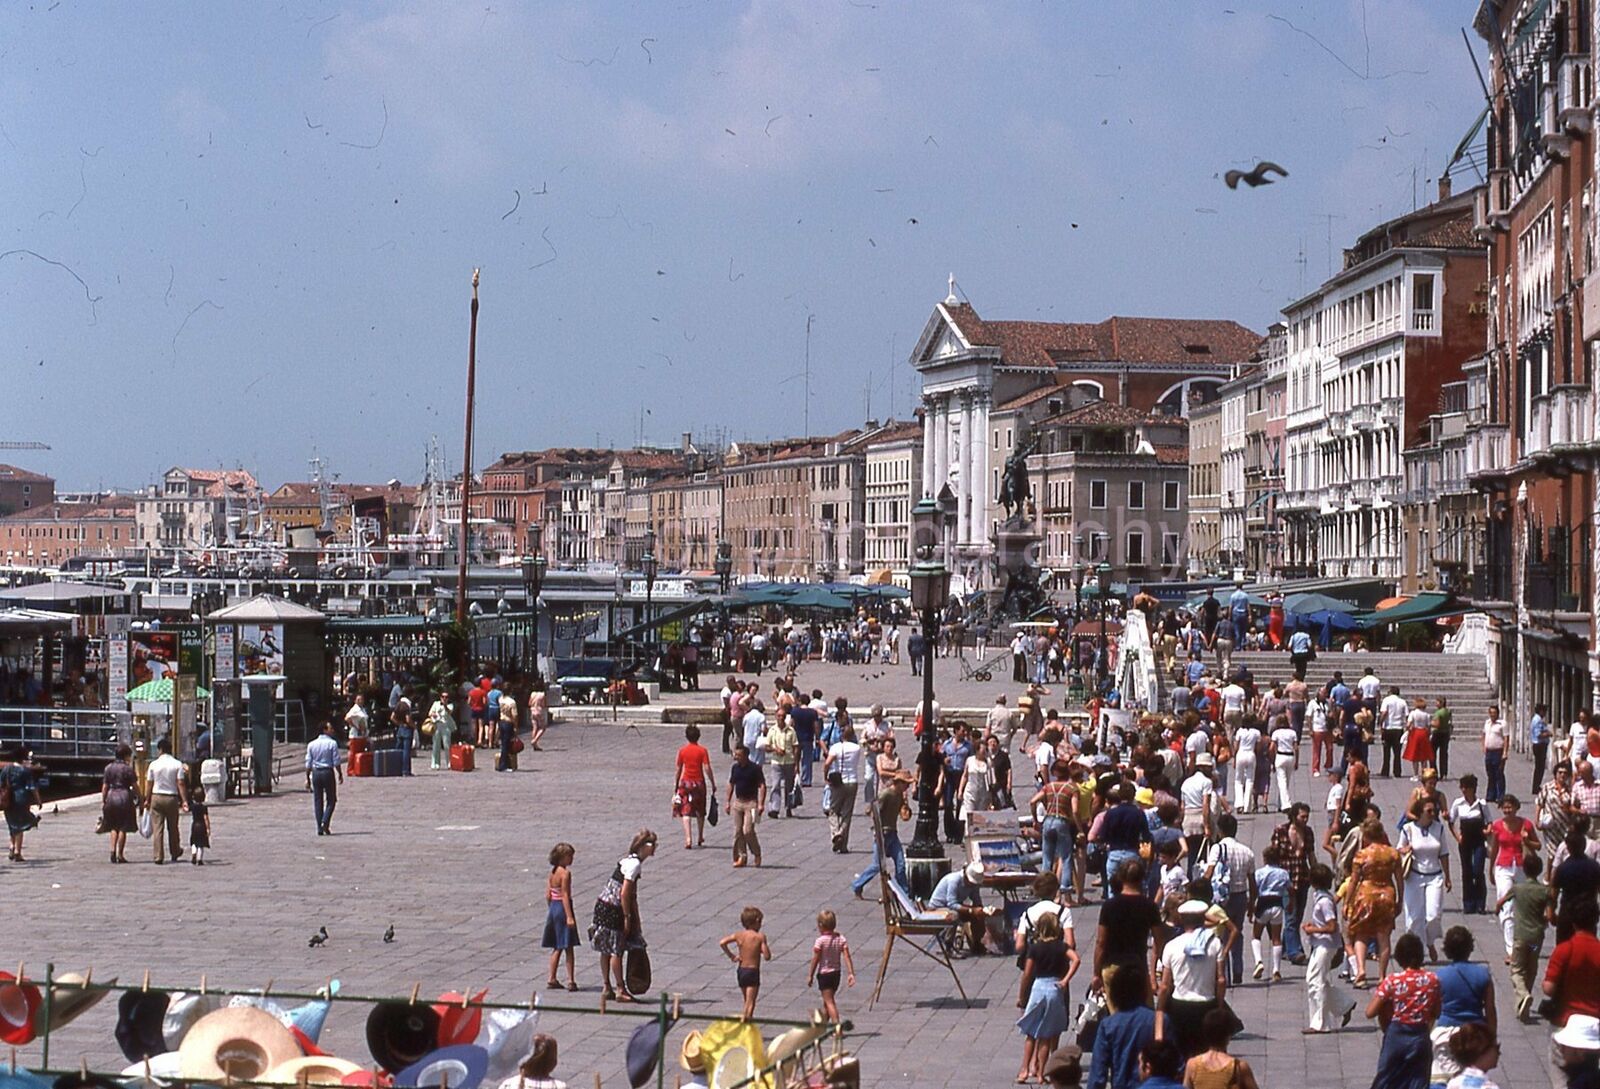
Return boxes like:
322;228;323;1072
902;497;950;896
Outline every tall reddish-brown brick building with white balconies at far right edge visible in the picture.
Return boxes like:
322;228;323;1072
1469;0;1600;724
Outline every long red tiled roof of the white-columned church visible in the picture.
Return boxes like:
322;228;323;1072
944;302;1261;368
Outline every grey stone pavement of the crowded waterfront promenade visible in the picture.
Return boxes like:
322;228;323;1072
0;687;1550;1087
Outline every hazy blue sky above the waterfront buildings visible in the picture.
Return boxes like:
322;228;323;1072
0;0;1483;488
